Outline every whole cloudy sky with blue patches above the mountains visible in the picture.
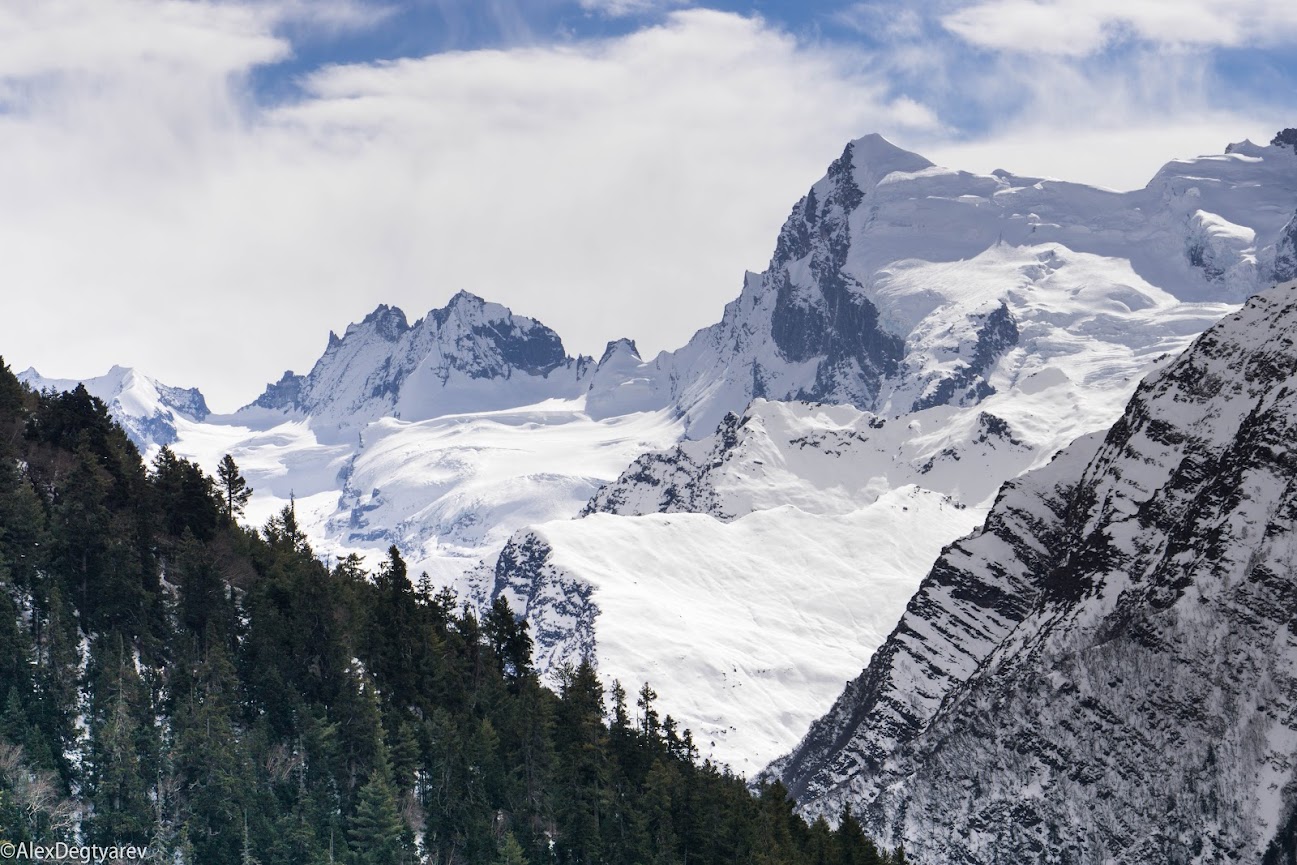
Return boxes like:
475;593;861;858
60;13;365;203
0;0;1297;411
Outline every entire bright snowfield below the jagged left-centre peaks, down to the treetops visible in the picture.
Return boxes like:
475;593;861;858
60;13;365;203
159;376;682;585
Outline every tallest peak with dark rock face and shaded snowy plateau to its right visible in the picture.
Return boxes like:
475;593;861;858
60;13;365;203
614;135;1297;436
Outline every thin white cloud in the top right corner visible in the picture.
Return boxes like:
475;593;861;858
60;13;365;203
942;0;1297;57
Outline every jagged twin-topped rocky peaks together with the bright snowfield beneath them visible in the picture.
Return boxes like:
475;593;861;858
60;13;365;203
123;292;682;585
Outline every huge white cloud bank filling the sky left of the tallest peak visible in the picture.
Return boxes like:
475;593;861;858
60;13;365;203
0;0;934;409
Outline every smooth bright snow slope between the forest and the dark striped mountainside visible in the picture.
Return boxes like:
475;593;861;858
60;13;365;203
479;486;982;774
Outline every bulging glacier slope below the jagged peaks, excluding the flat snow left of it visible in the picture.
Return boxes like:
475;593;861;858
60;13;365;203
324;399;681;585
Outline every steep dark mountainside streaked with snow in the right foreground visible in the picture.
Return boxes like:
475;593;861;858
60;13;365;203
776;283;1297;864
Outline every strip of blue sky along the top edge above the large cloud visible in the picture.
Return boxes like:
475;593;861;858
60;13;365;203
253;0;1297;137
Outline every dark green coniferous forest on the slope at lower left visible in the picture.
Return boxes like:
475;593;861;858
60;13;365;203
0;362;904;865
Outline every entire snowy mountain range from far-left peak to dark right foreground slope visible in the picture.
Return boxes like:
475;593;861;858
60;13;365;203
22;135;1297;862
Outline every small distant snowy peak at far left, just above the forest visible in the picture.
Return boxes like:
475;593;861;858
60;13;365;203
18;366;211;453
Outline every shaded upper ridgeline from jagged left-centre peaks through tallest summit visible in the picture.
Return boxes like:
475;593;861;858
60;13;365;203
223;135;1297;451
